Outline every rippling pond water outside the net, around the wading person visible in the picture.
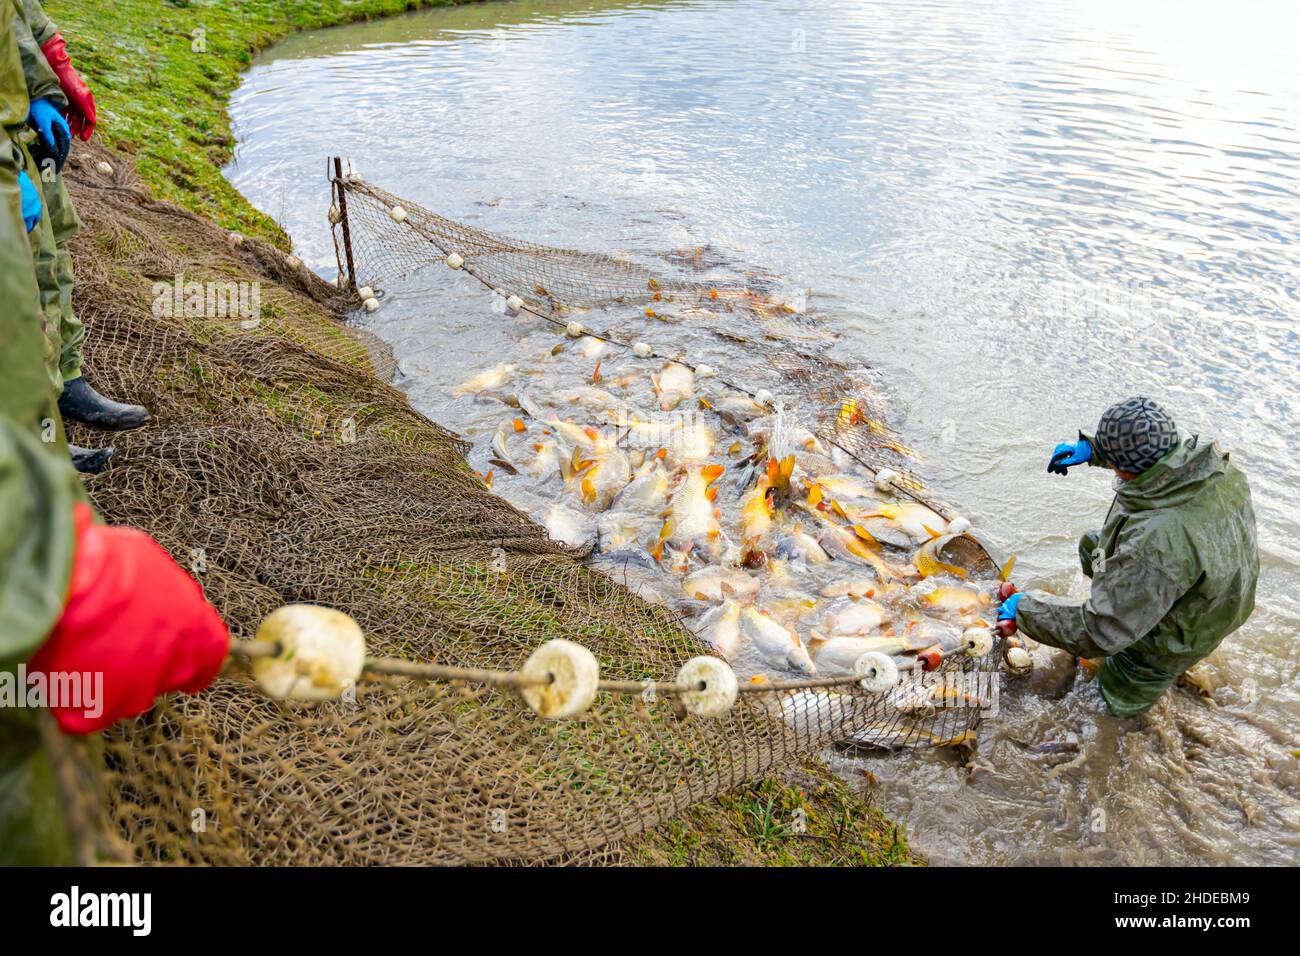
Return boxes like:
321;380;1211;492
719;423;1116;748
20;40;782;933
229;0;1300;864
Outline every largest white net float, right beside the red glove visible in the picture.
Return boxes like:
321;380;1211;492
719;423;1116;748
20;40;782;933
252;604;365;701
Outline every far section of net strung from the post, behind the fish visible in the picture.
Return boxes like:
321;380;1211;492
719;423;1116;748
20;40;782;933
330;174;935;504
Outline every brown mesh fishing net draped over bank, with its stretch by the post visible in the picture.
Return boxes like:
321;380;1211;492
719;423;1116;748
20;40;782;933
52;150;997;865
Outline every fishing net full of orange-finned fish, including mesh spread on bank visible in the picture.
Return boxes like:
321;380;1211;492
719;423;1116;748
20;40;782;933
52;157;1004;865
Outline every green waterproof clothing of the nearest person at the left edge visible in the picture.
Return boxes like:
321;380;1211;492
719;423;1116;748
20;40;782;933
0;0;82;865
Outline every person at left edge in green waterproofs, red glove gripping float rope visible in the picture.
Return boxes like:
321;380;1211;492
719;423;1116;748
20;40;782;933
0;0;229;865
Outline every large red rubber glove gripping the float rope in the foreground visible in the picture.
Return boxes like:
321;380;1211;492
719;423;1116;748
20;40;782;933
27;503;230;734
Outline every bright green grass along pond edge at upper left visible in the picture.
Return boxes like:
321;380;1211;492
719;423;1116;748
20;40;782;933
46;0;473;248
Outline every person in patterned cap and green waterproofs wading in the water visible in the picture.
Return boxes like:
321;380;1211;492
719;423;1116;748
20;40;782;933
998;398;1260;717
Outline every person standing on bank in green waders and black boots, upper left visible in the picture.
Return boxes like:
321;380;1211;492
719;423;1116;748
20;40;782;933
16;0;150;472
